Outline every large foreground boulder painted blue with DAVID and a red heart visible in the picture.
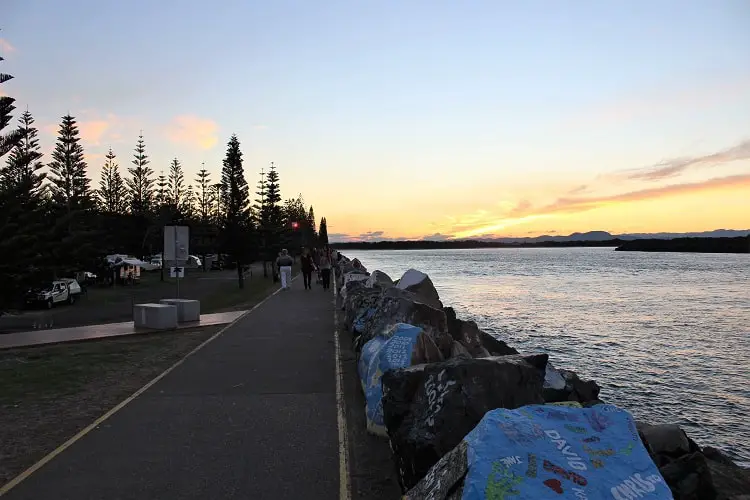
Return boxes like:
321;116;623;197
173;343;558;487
404;405;672;500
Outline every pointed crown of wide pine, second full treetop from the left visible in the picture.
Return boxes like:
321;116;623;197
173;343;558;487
48;114;93;213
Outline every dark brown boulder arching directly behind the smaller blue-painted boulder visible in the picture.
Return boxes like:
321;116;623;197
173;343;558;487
355;287;452;358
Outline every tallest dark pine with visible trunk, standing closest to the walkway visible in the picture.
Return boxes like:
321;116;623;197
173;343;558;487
221;135;250;288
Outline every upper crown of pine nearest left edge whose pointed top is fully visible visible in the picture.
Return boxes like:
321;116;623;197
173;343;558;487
0;110;47;201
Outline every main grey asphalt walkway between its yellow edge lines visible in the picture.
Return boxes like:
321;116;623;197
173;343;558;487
3;279;339;500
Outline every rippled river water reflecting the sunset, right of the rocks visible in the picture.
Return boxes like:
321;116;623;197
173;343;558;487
344;248;750;465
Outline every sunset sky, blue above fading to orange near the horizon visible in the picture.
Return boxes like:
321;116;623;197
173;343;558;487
0;0;750;239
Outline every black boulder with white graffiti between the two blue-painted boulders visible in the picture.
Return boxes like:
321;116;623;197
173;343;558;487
382;354;547;490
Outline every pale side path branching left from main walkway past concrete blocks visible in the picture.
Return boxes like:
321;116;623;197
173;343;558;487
0;311;245;349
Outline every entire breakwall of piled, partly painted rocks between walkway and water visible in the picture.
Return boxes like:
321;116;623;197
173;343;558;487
335;256;750;500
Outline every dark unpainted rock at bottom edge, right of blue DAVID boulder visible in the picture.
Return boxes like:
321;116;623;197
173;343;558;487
659;452;717;500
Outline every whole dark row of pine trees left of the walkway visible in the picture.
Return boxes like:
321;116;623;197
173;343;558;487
0;49;328;313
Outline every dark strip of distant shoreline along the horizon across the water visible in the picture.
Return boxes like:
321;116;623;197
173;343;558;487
331;236;750;253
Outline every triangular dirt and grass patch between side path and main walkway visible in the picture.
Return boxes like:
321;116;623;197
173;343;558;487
0;325;224;484
